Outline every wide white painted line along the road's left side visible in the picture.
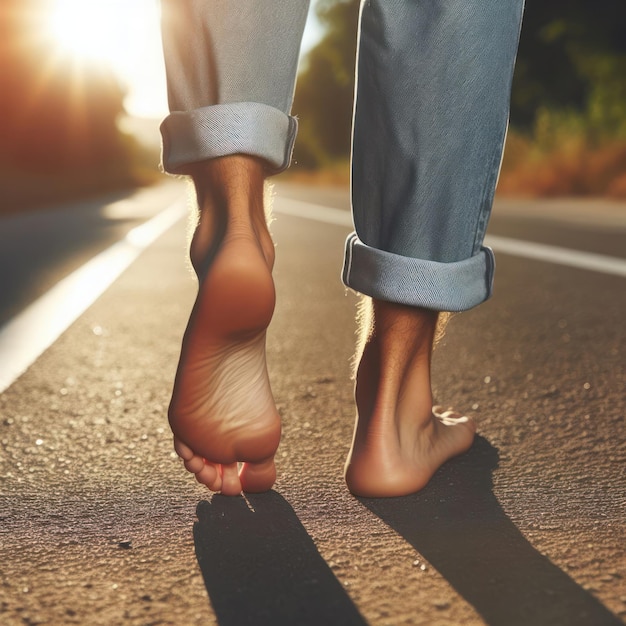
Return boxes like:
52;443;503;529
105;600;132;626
0;200;187;393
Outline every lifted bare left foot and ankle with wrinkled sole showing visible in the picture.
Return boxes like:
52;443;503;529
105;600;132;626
169;156;281;495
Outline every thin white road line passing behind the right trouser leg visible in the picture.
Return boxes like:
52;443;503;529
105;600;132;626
274;198;626;276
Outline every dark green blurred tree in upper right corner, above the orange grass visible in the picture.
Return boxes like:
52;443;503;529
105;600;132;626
511;0;626;132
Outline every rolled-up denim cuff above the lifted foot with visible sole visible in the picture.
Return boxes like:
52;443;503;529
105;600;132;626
161;102;298;174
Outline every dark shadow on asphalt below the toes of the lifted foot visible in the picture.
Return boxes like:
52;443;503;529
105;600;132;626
194;491;366;626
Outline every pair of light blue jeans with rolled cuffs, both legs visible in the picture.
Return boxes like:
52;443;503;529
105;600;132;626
161;0;523;311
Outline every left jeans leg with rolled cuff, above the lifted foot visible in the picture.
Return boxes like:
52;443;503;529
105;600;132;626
161;0;309;174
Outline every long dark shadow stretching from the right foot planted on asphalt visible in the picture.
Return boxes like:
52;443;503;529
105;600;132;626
359;437;621;626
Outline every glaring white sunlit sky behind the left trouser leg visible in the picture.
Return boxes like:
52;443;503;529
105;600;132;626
45;0;321;118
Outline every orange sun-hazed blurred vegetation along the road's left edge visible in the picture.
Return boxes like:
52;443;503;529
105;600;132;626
0;0;159;212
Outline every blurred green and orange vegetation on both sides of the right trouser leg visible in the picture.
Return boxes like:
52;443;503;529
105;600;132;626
291;0;626;198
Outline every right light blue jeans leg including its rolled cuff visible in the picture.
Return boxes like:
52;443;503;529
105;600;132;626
343;0;523;310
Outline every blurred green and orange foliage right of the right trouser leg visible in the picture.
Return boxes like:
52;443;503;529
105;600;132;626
499;0;626;197
